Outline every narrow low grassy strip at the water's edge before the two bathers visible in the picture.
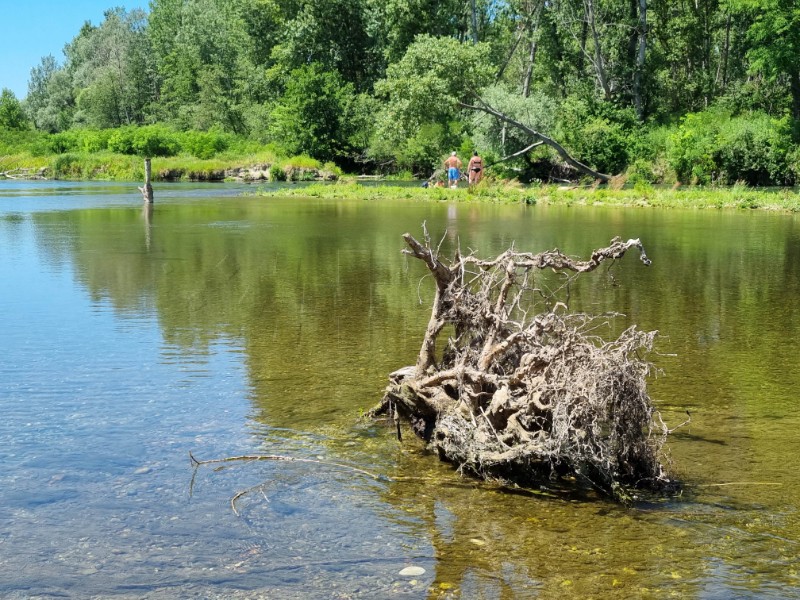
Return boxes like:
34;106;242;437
259;180;800;212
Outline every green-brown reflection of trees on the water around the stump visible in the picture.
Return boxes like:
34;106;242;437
23;199;800;598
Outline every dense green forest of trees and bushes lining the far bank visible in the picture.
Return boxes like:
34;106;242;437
0;0;800;185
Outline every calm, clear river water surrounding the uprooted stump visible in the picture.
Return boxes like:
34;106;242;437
0;182;800;599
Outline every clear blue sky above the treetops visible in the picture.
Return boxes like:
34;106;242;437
0;0;149;100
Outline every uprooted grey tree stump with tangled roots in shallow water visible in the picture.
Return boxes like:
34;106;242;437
370;230;674;500
